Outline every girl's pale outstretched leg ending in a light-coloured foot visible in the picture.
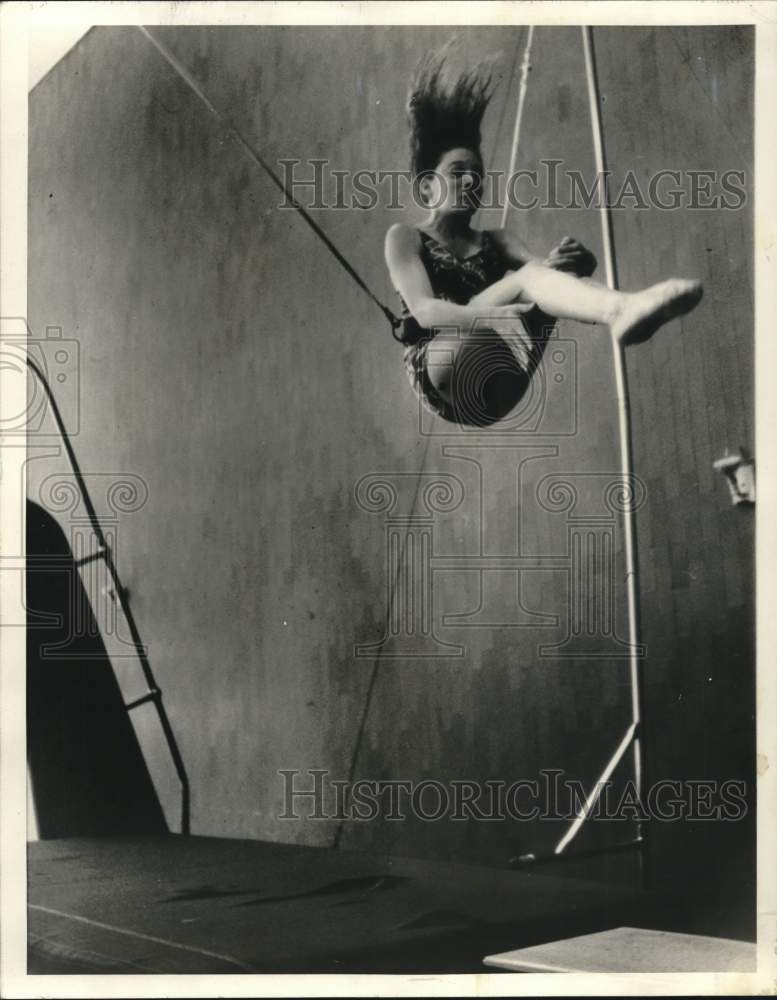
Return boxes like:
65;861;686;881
470;263;702;343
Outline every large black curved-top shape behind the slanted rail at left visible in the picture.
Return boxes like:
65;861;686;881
26;500;167;839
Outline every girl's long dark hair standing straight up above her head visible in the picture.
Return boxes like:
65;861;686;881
407;43;492;177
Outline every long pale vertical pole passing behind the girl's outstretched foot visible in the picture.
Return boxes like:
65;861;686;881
582;27;648;885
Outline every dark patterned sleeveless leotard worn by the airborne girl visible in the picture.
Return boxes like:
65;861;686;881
399;229;548;423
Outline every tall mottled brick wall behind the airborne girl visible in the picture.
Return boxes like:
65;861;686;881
29;19;754;916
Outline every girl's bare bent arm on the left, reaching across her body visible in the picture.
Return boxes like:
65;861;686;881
385;223;526;330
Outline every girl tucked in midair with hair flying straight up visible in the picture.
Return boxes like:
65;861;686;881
385;54;702;425
